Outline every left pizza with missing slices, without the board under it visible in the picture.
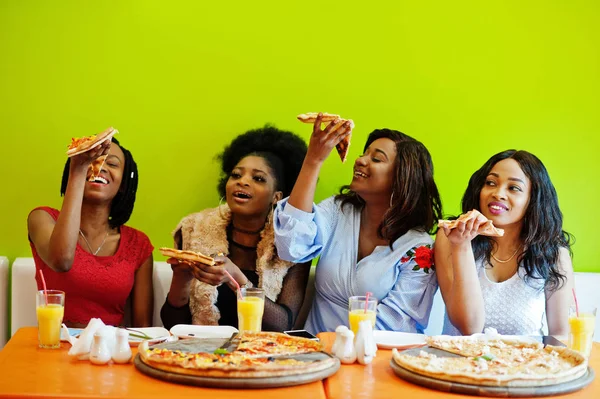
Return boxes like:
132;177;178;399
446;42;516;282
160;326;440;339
138;332;338;378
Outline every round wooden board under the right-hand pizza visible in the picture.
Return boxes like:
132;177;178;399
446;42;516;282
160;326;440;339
390;347;594;398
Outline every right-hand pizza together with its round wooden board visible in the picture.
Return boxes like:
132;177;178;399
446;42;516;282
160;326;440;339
391;335;594;396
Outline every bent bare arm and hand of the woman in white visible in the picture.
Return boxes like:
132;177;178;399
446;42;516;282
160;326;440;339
434;215;487;335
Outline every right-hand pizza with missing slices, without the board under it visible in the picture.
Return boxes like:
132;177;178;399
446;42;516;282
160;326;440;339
393;335;587;387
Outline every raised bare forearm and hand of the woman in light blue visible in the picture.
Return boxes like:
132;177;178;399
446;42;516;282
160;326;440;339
288;113;351;212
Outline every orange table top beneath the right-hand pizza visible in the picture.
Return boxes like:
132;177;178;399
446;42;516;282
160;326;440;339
319;333;600;399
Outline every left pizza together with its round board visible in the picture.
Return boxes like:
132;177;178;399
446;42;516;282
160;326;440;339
134;332;340;388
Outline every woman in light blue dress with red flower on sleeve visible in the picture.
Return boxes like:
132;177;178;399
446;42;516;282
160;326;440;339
274;117;442;333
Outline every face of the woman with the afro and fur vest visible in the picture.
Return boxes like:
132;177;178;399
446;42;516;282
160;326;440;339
225;155;281;218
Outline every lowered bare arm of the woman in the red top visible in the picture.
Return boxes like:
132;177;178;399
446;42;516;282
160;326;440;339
131;255;154;327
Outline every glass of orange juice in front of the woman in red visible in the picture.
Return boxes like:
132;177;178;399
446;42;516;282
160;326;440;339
35;290;65;349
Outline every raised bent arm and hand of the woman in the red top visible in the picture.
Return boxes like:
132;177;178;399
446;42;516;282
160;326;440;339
27;140;110;272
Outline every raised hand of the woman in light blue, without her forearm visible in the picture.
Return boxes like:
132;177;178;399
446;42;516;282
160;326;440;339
306;112;352;163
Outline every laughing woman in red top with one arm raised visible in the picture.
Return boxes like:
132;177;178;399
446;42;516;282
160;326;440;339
27;139;153;327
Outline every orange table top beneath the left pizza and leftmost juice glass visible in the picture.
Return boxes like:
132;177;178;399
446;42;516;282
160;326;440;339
0;327;325;399
